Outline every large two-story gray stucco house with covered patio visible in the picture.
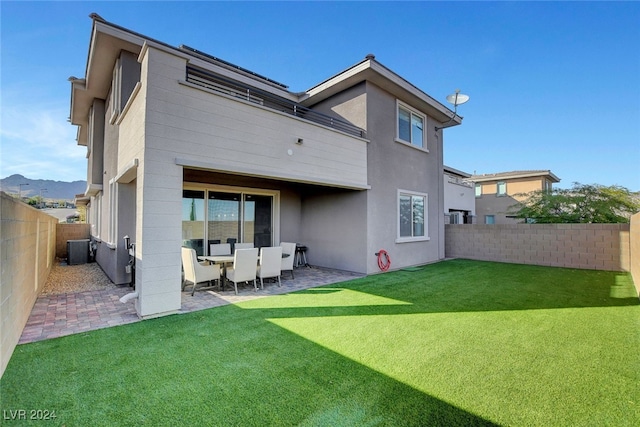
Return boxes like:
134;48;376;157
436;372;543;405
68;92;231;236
69;14;461;317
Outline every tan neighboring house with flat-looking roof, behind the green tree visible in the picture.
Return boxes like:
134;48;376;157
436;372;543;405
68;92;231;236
469;170;560;224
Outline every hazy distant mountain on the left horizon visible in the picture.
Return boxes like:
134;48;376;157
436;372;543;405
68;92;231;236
0;174;87;200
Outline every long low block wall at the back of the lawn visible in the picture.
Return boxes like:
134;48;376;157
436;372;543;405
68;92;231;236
445;224;631;271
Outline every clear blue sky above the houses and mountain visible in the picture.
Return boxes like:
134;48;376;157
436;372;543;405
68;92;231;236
0;0;640;191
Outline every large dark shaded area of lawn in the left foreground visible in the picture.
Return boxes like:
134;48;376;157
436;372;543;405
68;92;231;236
0;305;497;426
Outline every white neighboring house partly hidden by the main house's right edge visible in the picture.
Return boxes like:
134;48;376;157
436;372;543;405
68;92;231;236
444;165;476;224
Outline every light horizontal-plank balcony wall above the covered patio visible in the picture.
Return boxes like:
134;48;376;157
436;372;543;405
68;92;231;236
168;64;367;191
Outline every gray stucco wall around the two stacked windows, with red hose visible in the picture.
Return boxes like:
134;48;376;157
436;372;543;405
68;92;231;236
366;82;444;273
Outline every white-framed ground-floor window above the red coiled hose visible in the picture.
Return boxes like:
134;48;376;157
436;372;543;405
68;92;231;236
397;191;428;242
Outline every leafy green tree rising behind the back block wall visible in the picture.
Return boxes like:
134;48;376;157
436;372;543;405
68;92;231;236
509;182;640;223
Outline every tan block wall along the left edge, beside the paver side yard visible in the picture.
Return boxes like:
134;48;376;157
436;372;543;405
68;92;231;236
0;193;58;376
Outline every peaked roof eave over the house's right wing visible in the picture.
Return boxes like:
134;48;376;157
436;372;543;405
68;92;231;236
301;57;462;127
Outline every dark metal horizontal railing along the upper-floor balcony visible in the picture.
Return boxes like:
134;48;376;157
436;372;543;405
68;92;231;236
186;66;365;138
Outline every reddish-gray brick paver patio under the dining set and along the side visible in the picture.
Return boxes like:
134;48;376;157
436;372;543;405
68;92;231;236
19;263;363;344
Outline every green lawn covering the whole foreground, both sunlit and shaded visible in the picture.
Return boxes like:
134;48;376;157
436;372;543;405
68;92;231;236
0;260;640;426
